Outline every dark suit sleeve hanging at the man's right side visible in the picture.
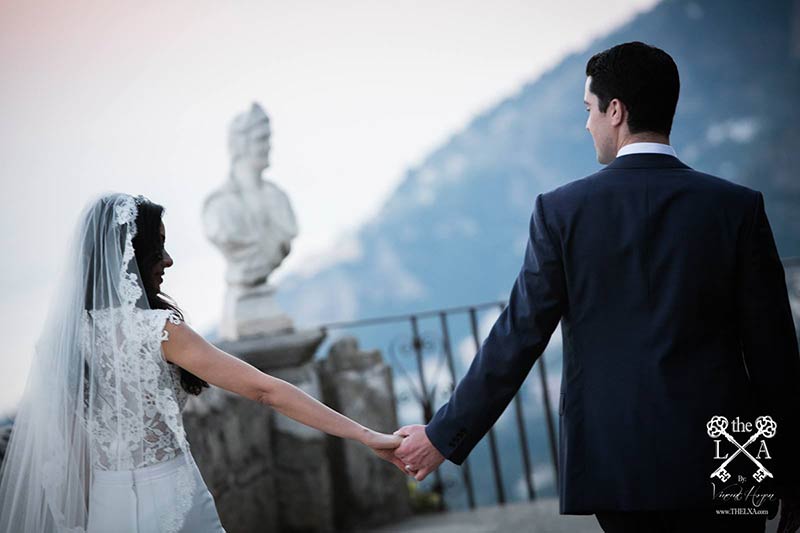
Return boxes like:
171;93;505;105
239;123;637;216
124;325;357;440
737;192;800;494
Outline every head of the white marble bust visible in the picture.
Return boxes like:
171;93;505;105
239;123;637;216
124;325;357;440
228;102;271;170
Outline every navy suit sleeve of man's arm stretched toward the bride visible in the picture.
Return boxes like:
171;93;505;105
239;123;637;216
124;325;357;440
425;194;566;464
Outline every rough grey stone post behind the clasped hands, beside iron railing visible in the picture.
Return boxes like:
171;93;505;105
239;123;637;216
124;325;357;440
318;338;411;531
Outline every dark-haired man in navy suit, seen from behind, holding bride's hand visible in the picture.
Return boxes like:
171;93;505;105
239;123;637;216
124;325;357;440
393;42;800;532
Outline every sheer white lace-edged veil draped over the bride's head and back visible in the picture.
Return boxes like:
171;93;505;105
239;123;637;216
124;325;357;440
0;194;195;533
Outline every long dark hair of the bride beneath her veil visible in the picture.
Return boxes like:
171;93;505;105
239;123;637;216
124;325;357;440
133;197;208;395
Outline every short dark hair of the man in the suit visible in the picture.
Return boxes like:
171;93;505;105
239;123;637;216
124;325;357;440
586;41;681;135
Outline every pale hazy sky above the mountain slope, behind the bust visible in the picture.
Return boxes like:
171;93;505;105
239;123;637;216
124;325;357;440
0;0;656;411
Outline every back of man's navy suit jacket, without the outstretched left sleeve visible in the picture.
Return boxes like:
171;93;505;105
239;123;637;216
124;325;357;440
541;153;800;513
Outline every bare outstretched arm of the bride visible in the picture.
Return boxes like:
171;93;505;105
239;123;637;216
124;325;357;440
161;321;402;449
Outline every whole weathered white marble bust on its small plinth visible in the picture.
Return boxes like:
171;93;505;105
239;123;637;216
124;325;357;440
203;103;297;340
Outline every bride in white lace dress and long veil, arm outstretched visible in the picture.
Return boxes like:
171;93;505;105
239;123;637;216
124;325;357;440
0;194;402;533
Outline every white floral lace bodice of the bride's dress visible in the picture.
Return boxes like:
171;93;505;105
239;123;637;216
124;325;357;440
81;308;187;470
